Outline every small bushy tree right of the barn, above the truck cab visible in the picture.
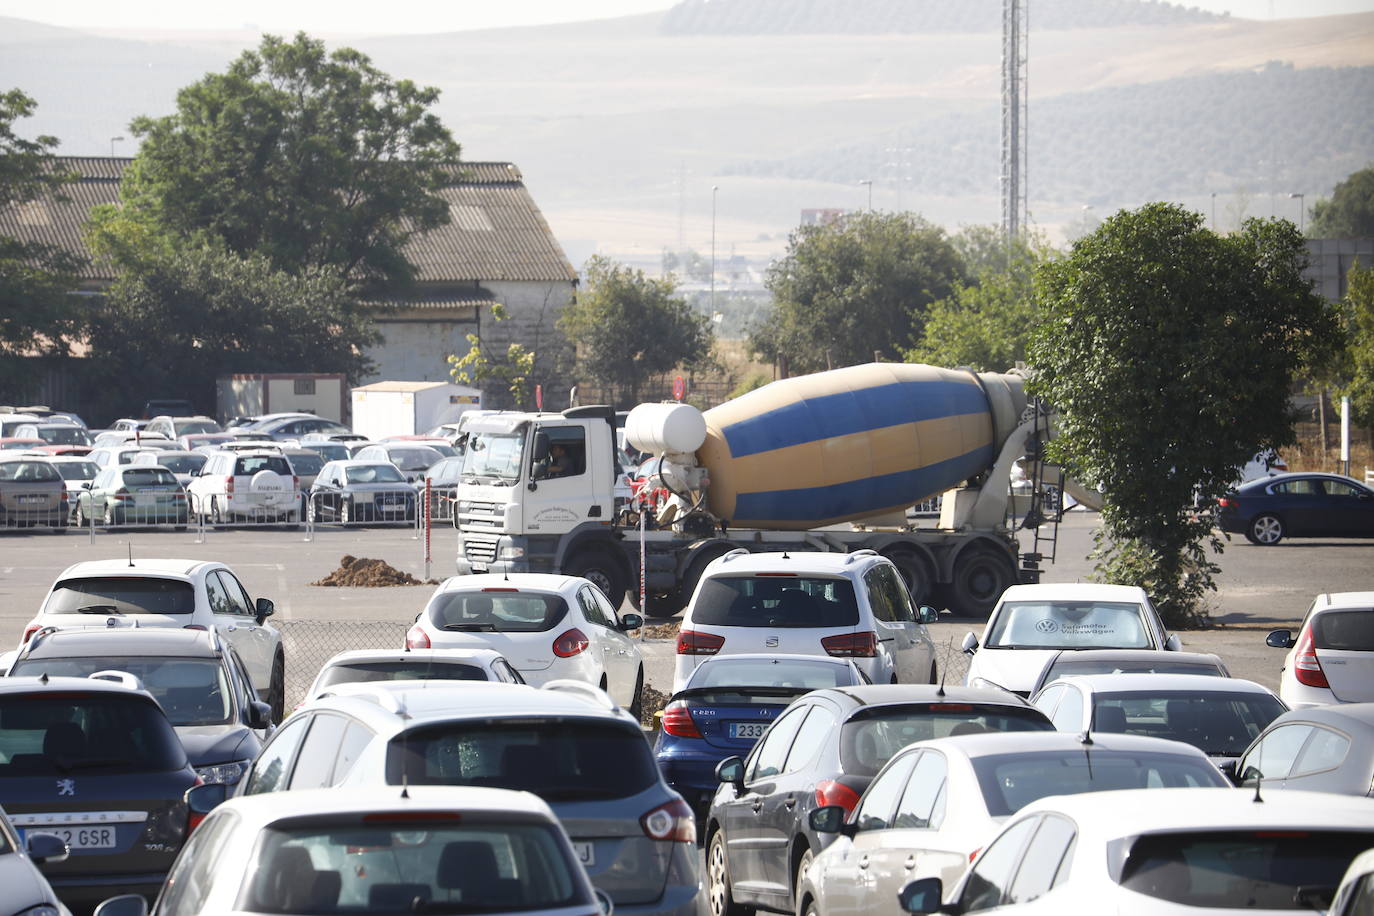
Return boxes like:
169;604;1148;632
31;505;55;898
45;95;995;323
558;255;714;404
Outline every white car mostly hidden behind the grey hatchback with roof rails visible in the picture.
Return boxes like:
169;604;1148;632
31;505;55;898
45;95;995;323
305;648;525;703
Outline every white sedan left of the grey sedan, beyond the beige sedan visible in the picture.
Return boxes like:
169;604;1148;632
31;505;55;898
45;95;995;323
1031;674;1287;766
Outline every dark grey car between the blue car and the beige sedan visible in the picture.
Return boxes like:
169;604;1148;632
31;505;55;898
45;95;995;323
705;684;1054;916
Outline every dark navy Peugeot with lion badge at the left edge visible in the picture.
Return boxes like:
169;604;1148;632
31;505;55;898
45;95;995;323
0;674;196;909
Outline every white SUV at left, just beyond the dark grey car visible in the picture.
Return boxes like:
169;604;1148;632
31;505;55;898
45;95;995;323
21;559;286;722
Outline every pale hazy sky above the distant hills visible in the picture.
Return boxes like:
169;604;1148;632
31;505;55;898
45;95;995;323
0;0;1374;33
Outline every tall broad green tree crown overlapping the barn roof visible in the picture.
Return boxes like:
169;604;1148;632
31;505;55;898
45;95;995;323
112;33;459;286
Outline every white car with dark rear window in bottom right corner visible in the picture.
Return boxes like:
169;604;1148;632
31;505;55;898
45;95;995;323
900;788;1374;916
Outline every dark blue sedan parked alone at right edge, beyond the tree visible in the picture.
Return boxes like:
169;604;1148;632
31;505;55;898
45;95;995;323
1217;474;1374;547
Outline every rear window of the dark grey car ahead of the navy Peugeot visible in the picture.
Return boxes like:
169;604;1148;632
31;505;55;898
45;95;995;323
10;656;234;725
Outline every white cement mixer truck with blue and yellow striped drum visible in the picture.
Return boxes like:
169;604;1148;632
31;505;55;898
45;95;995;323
453;363;1048;617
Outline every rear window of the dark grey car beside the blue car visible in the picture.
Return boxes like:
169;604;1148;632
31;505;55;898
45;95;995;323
840;703;1054;776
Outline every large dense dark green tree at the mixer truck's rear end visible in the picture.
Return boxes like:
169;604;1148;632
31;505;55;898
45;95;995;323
1031;203;1341;626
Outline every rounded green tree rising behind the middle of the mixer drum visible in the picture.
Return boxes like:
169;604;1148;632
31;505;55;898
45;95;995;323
749;213;965;374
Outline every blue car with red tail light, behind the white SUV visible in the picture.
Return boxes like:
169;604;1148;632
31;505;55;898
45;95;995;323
654;655;870;824
